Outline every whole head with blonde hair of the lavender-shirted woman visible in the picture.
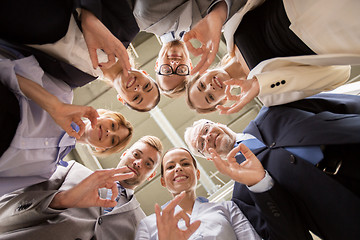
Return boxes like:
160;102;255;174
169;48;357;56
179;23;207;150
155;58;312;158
78;109;133;156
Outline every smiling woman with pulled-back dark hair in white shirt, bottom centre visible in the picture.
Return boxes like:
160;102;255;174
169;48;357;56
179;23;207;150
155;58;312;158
135;148;260;240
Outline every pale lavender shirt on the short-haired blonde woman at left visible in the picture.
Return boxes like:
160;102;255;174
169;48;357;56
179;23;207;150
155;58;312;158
0;55;75;195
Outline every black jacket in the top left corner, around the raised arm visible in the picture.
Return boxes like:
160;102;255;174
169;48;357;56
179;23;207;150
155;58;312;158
0;0;139;47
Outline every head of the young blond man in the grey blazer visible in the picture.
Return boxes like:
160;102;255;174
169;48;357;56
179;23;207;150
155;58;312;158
117;136;163;189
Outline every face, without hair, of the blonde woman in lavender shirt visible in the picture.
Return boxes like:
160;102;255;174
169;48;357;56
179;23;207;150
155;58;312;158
82;115;130;151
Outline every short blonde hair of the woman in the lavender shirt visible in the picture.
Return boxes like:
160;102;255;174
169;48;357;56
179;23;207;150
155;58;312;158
93;109;134;157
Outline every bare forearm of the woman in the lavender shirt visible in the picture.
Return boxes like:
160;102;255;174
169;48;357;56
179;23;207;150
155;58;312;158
16;75;62;115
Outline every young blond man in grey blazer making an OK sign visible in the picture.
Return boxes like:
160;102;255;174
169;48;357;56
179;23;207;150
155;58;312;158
0;136;162;240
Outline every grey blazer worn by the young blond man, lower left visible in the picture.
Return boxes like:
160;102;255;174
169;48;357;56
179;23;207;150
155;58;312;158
0;161;145;240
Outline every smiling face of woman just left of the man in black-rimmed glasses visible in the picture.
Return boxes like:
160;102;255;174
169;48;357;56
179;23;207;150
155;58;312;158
114;69;160;111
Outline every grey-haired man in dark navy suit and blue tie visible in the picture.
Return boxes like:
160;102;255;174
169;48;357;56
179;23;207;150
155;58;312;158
185;94;360;239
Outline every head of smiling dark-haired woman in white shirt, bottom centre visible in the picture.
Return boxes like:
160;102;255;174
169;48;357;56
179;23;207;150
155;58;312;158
160;148;200;196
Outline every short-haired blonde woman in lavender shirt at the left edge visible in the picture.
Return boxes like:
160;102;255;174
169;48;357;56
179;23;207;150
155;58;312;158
0;41;133;195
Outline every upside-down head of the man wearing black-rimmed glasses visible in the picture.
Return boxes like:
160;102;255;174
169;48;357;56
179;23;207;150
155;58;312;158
155;40;192;98
